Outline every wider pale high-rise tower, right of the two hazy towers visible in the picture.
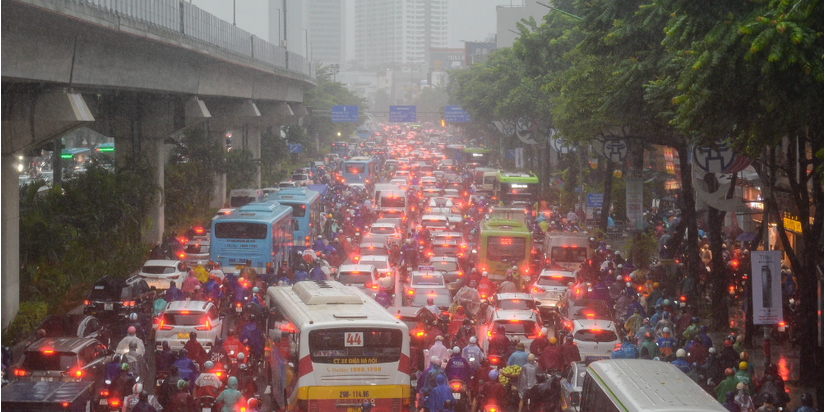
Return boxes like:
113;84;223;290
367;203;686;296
355;0;449;67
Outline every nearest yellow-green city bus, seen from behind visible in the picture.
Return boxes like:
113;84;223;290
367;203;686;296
477;218;531;280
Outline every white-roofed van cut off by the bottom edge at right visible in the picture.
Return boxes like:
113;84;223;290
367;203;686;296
576;359;727;412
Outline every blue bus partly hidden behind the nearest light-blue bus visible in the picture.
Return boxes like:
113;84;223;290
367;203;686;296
266;187;324;252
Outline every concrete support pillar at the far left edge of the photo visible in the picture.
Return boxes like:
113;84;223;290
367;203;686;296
0;154;20;328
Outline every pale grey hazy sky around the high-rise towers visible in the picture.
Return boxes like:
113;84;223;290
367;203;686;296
191;0;522;56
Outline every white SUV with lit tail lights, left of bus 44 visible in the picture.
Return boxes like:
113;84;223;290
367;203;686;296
155;300;223;352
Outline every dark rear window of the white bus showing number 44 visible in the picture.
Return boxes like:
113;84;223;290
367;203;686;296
309;328;403;365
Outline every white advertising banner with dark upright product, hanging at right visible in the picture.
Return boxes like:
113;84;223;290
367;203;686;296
751;250;782;325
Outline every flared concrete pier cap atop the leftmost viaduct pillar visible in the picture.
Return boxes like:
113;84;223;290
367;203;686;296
2;89;95;155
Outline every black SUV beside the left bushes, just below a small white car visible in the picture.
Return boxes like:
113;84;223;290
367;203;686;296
83;276;154;323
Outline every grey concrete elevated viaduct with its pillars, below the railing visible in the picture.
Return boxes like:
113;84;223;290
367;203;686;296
0;0;313;327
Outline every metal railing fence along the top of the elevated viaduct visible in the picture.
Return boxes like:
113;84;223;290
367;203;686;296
72;0;315;78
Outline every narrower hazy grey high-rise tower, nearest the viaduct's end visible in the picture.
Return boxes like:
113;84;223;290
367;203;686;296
305;0;346;65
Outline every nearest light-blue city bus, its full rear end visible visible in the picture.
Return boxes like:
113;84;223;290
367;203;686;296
209;201;292;274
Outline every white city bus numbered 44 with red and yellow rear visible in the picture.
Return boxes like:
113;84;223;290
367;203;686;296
266;281;410;412
